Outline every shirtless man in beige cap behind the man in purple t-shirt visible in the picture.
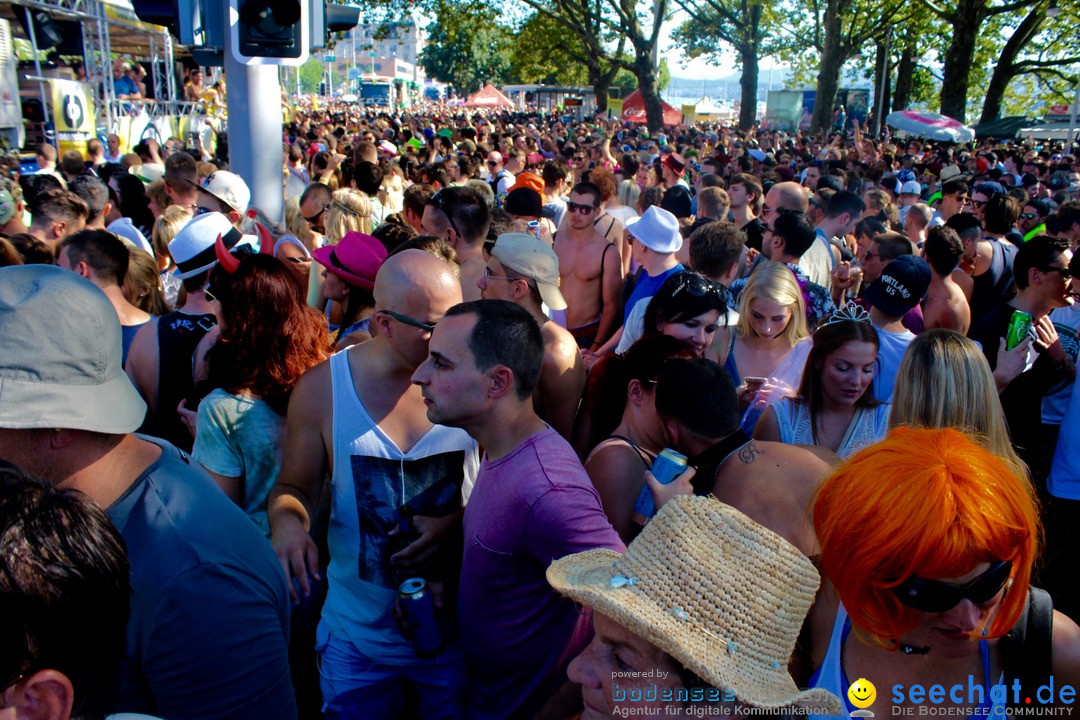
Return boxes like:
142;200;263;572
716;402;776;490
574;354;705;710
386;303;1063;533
480;232;585;440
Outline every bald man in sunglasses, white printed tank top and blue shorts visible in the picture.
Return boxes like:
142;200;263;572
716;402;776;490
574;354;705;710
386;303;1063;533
268;249;480;718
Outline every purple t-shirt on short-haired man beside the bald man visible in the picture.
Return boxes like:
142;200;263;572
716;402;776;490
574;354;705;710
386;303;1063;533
458;429;625;719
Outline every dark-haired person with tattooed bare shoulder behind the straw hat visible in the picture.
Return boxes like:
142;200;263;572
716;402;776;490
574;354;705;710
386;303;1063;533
657;358;839;556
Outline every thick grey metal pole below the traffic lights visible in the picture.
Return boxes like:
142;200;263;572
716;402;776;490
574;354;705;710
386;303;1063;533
224;33;285;222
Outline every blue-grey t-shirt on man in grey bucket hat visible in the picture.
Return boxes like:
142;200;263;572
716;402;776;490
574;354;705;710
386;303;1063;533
107;435;296;720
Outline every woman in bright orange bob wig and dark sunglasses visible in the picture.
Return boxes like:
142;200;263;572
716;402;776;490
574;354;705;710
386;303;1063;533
805;427;1080;717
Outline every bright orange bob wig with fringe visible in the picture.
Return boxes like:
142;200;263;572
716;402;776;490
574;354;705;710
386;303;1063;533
813;427;1040;648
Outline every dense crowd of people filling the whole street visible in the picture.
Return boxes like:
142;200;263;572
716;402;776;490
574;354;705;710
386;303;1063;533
0;106;1080;719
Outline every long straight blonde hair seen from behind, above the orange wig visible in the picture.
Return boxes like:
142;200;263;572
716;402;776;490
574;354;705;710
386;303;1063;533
889;328;1028;477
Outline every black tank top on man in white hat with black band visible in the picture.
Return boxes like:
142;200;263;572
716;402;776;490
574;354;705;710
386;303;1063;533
140;310;217;452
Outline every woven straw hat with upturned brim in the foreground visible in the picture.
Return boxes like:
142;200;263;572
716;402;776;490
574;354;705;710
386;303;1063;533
548;495;843;715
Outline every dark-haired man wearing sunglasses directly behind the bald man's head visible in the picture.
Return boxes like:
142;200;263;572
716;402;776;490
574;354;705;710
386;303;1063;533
420;188;491;302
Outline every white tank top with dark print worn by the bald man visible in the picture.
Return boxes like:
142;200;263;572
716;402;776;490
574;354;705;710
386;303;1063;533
323;351;480;664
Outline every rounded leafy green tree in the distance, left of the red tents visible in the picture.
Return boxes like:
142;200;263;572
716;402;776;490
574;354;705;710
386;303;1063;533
420;0;513;93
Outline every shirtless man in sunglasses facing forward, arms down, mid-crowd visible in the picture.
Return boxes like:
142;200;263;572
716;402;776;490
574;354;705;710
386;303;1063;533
552;182;623;351
